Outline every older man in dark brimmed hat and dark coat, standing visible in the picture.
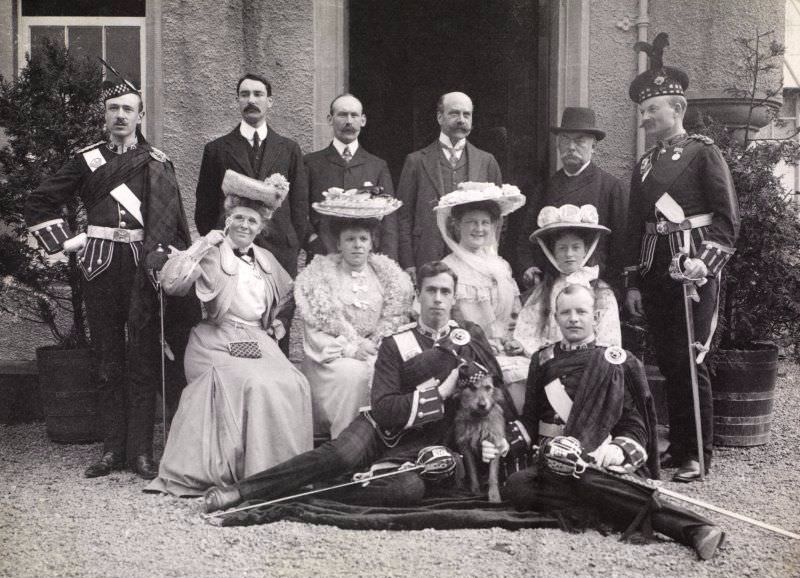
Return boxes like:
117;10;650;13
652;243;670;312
517;107;628;286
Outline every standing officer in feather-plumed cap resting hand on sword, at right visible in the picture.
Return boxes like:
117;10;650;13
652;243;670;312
625;33;739;482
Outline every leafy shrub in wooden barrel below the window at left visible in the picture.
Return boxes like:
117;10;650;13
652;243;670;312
0;41;104;442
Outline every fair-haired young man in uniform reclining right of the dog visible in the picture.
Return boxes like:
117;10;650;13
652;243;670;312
500;285;725;560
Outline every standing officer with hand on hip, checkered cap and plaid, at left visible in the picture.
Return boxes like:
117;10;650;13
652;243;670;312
25;71;195;479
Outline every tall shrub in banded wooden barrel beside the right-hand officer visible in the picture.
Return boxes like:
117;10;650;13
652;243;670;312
688;30;800;446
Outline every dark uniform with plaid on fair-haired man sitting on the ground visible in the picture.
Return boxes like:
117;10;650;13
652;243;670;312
503;344;711;546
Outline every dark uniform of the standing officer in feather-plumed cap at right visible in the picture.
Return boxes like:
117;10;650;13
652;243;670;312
626;134;739;465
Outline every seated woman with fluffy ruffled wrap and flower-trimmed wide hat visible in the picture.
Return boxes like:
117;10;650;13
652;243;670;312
294;187;414;438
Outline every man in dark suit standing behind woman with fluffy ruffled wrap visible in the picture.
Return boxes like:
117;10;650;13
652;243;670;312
304;94;397;259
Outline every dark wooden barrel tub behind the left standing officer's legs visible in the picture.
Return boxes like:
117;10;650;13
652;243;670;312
36;346;101;444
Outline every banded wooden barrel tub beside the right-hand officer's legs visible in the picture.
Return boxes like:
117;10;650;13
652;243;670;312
711;343;778;446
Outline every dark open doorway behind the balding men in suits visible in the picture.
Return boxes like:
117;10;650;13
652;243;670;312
349;0;549;259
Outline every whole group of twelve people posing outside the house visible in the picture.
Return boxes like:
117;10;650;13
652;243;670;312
26;32;738;558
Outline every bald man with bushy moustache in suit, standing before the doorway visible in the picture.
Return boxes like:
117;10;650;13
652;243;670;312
397;92;502;277
